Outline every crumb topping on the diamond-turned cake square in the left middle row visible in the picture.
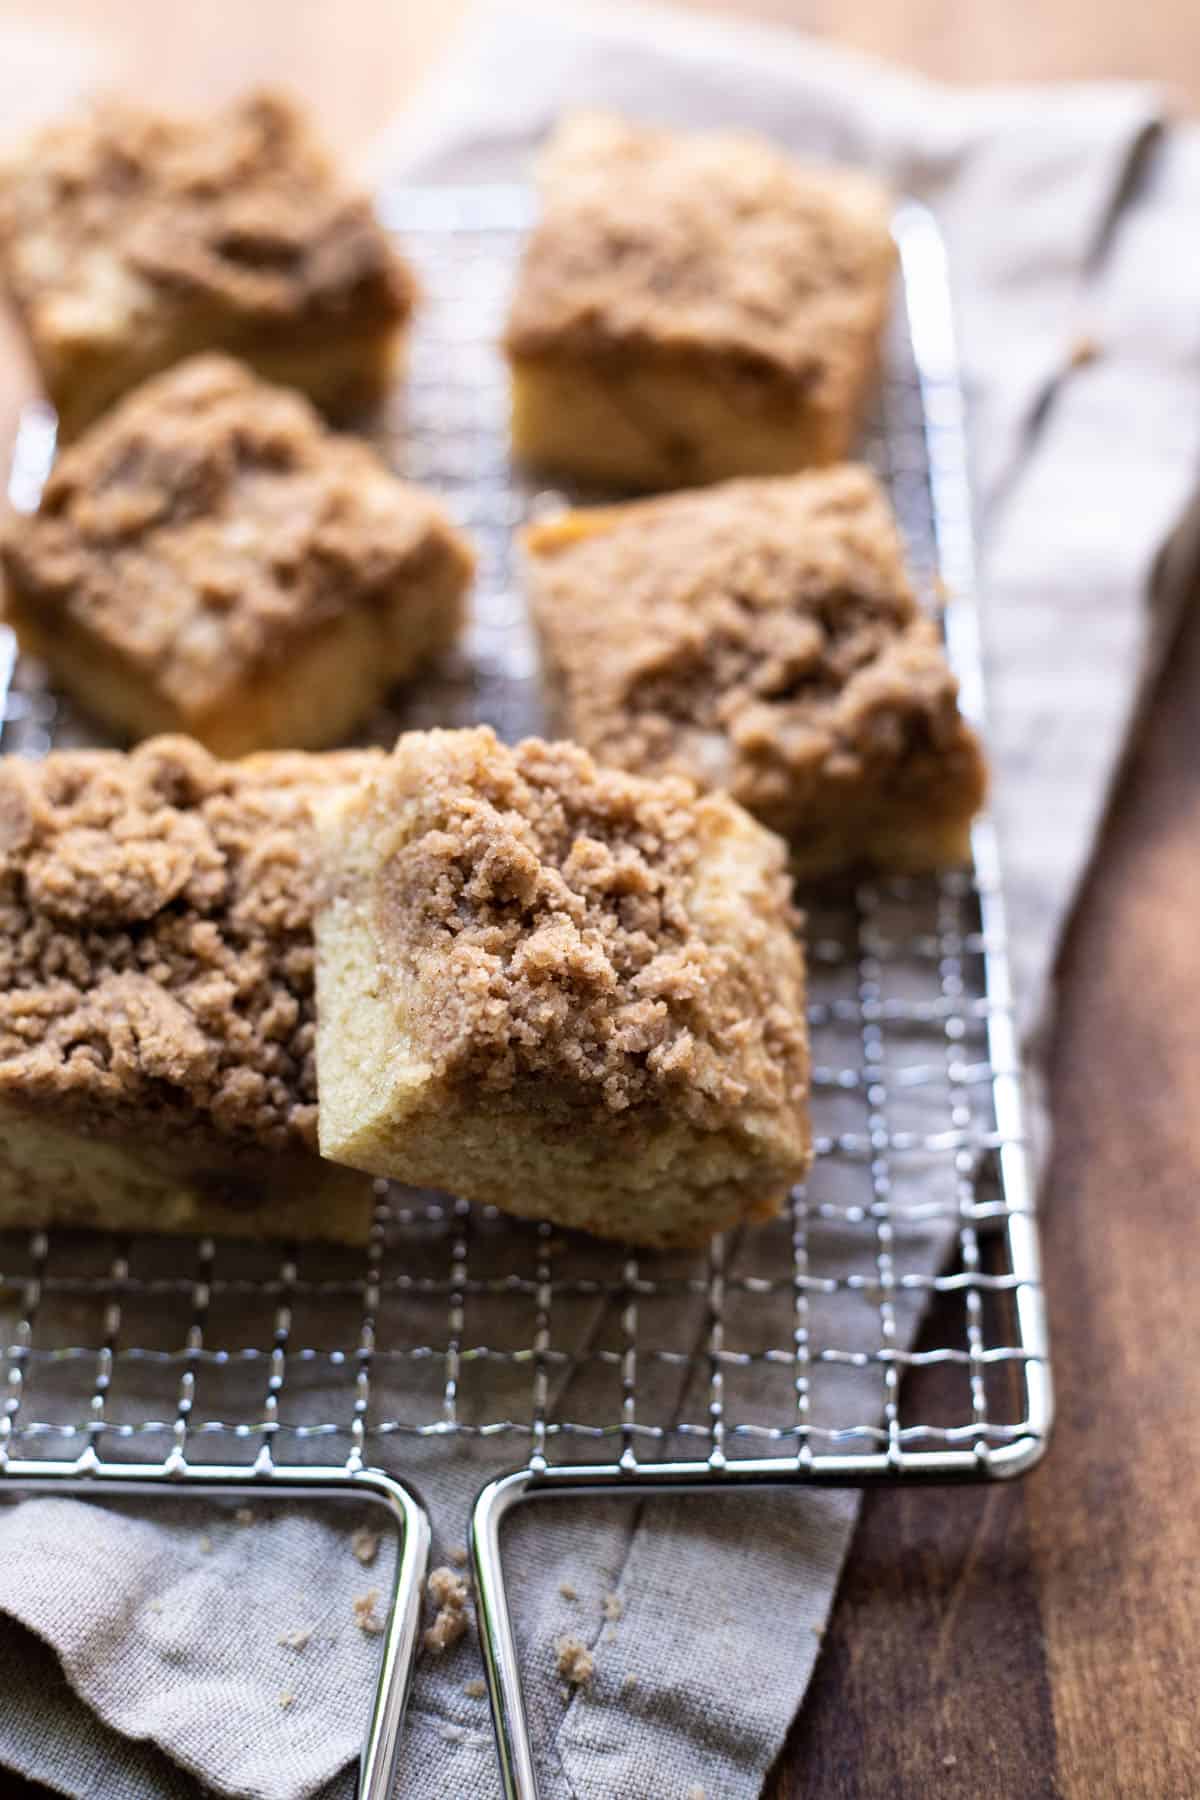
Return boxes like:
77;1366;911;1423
0;356;471;718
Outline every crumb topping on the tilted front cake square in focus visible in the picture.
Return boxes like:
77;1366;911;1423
356;729;806;1129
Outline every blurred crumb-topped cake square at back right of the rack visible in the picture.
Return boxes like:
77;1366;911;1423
507;113;894;488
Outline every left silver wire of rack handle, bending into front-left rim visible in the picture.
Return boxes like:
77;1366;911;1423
0;1451;432;1800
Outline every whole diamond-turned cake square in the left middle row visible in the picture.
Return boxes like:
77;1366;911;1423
0;356;473;756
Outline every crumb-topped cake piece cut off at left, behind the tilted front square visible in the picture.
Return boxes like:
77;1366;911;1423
0;738;378;1244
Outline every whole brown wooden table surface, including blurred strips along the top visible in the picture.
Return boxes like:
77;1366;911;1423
0;0;1200;1800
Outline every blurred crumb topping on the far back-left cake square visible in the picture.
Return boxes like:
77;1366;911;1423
0;92;414;342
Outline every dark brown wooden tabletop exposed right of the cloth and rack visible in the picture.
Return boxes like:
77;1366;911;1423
770;596;1200;1800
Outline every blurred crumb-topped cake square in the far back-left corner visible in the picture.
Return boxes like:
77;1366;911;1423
0;92;416;437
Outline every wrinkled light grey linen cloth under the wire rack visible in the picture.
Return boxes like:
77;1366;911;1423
0;0;1200;1800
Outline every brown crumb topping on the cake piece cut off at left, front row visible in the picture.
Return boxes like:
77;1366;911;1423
0;738;374;1150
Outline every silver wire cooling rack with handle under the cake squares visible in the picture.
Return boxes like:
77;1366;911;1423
0;189;1052;1800
